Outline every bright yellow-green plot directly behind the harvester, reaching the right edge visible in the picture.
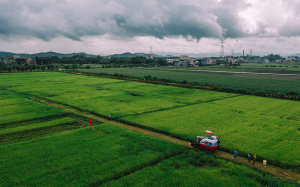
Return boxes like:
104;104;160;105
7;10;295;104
121;96;300;168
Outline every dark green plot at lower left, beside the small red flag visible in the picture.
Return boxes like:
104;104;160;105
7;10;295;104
0;124;186;186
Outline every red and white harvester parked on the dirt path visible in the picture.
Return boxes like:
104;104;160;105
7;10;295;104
190;130;220;150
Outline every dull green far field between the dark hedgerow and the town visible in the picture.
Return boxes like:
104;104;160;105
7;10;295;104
78;68;300;94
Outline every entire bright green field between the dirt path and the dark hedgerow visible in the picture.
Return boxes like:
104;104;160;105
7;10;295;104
0;73;300;166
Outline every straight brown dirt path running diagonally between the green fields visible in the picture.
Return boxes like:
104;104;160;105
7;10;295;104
31;97;300;184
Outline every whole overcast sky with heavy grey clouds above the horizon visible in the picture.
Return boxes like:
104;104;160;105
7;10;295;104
0;0;300;55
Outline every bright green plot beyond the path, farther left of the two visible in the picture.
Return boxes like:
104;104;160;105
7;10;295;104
0;73;235;117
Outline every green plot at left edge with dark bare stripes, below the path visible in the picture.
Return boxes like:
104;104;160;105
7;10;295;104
0;90;91;144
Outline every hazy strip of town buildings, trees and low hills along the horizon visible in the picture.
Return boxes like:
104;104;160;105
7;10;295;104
0;53;300;67
